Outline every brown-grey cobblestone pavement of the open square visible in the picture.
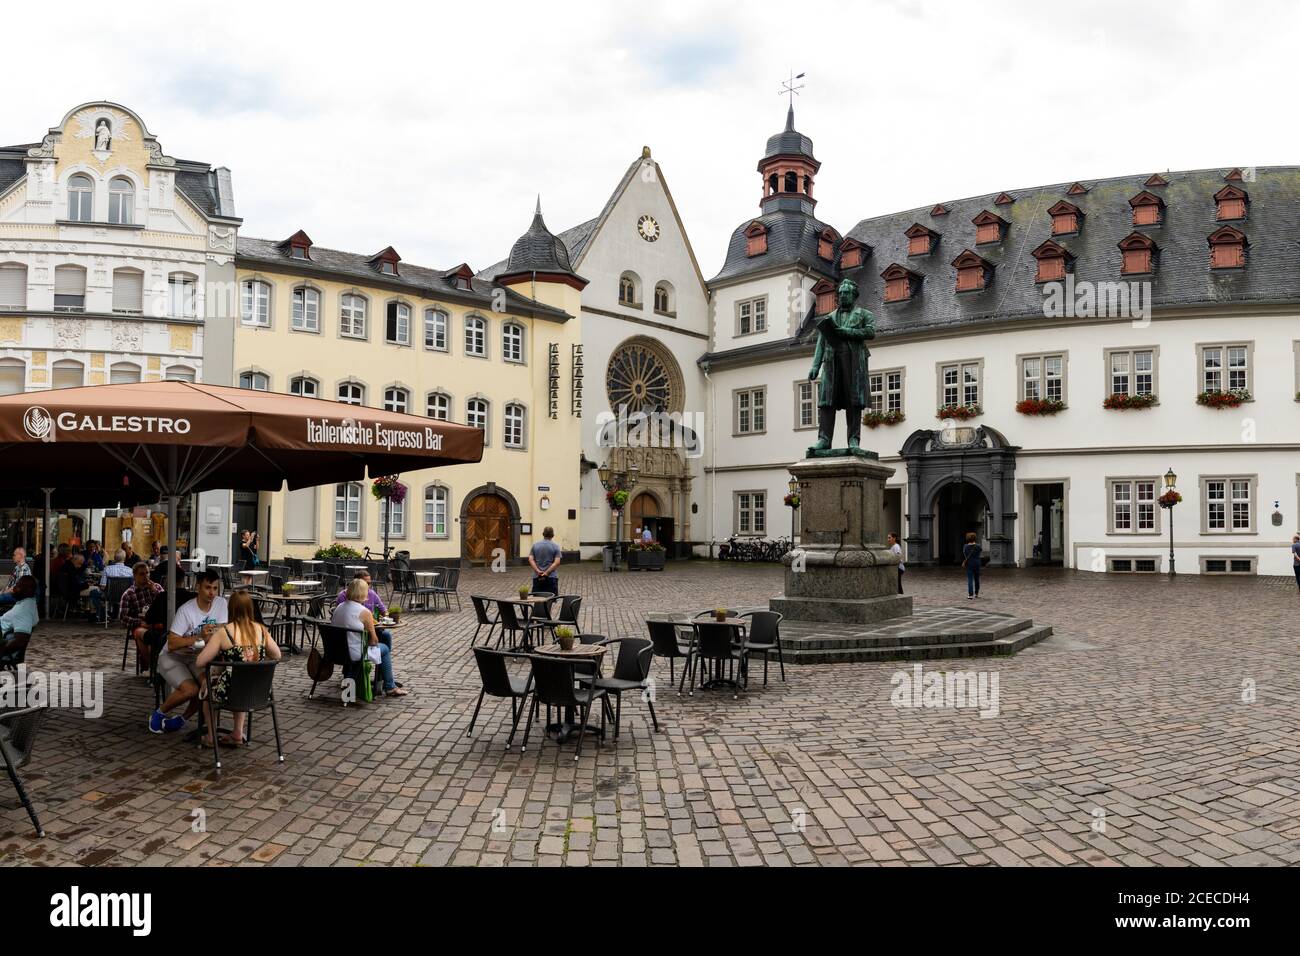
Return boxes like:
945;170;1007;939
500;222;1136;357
0;562;1300;866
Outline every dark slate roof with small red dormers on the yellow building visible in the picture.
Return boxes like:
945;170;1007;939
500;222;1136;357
235;235;571;320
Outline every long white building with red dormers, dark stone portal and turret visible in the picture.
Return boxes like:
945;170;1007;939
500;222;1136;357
701;111;1300;574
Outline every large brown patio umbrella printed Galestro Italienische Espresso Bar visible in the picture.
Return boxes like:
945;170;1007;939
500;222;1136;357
0;381;484;614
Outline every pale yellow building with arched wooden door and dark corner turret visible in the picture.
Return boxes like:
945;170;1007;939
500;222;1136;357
234;208;585;562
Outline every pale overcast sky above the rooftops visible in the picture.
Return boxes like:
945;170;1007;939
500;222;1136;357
12;0;1300;278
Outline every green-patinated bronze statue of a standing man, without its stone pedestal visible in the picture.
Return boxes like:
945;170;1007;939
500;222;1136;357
809;278;876;458
